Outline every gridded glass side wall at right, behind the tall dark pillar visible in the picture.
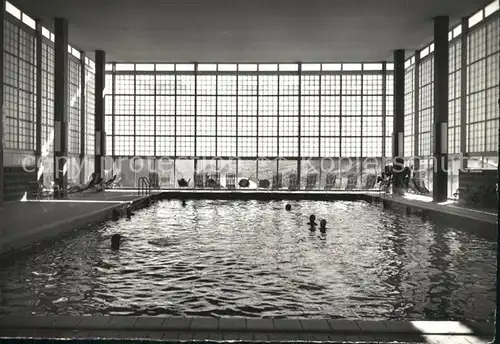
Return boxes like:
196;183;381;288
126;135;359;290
404;3;500;197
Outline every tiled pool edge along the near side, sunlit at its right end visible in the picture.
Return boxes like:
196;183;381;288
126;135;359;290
0;314;494;336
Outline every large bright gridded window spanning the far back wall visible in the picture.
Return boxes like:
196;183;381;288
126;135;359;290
106;63;393;159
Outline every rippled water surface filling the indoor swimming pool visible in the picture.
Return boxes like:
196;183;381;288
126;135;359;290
0;200;495;321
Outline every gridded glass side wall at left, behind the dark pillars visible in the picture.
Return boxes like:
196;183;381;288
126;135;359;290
3;3;95;186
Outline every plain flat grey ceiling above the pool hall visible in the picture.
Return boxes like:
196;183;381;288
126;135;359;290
9;0;491;62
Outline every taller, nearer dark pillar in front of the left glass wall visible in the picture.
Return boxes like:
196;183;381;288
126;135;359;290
54;18;68;196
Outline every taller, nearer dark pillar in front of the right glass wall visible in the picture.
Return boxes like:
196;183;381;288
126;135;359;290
432;16;450;202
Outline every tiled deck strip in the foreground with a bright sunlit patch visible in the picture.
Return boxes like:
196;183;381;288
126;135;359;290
0;315;493;344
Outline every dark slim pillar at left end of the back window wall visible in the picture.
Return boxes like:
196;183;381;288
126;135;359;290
95;50;106;178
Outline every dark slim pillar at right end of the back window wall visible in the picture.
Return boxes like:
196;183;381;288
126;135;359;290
392;49;405;159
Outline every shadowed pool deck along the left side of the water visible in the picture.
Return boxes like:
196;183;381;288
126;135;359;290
0;191;154;256
